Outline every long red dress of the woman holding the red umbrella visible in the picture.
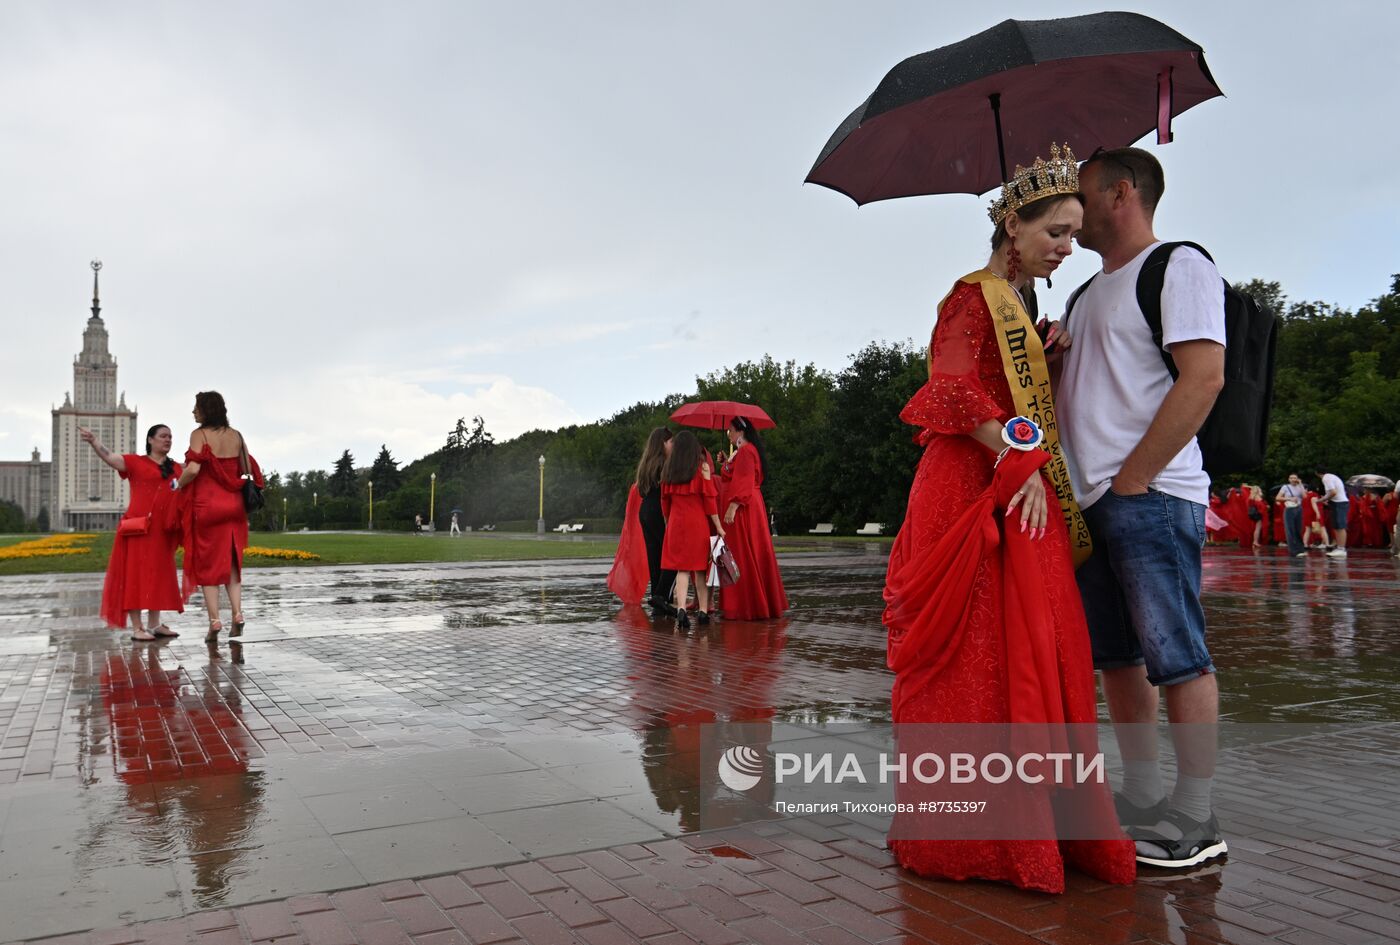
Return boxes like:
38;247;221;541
720;442;787;620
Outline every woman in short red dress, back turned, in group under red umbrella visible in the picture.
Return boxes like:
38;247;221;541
661;430;724;630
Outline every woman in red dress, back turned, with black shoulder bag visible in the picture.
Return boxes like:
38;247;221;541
178;391;263;641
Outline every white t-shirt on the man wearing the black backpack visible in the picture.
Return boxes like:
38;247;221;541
1056;244;1225;508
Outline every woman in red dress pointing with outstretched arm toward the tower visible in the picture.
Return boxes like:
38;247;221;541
78;424;185;643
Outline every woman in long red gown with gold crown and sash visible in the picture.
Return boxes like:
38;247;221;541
885;161;1135;892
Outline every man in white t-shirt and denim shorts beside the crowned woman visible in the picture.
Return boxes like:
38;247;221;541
1056;148;1225;867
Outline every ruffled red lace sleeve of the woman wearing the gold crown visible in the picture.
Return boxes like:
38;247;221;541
899;283;1009;442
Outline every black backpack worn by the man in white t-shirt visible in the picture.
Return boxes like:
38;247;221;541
1065;241;1278;476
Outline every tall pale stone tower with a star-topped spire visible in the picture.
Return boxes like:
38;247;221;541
49;259;144;532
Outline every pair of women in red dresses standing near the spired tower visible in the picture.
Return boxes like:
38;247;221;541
80;391;263;643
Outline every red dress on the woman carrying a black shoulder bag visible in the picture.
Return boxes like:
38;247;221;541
183;444;263;598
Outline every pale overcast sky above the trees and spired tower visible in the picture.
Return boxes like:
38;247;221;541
0;0;1400;472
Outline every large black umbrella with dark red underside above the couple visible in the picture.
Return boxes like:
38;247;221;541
806;13;1224;204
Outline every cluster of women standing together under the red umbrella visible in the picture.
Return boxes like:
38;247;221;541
608;417;788;629
